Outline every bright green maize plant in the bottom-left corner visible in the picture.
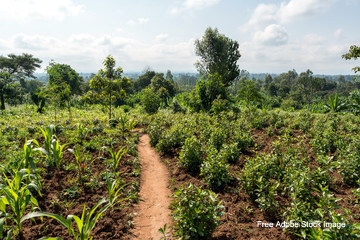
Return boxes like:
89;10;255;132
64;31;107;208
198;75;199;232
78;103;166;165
0;169;41;239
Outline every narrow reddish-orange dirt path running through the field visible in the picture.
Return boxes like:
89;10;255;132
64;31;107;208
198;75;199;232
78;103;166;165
133;134;171;240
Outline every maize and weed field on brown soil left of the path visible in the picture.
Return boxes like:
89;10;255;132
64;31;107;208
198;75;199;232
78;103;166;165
0;107;140;239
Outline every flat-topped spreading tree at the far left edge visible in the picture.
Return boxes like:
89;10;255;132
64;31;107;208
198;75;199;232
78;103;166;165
0;53;42;111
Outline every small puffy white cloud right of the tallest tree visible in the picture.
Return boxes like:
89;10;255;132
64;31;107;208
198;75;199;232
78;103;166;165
254;24;288;46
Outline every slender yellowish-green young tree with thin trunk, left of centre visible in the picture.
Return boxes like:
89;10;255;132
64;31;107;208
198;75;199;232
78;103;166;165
87;55;130;119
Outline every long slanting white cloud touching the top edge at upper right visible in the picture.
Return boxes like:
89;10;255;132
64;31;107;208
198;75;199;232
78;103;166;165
242;0;337;31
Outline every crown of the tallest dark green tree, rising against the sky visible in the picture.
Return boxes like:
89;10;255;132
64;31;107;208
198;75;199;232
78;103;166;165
195;27;241;87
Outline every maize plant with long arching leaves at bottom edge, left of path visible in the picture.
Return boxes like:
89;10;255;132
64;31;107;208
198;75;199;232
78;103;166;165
21;199;111;240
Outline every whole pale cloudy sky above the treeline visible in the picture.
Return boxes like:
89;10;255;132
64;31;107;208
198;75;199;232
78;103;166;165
0;0;360;74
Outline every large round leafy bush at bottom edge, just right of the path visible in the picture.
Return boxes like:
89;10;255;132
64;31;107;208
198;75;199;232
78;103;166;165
172;184;224;240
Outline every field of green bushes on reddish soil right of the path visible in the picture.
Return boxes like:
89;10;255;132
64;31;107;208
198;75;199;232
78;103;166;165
141;110;360;239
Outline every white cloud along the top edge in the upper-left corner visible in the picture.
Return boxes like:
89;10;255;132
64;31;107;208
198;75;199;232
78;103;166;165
0;0;83;20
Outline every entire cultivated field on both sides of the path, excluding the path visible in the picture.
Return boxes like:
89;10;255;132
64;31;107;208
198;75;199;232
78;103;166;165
0;105;360;239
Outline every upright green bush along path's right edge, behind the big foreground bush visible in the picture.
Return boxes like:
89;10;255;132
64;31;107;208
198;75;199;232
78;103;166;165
179;136;203;174
